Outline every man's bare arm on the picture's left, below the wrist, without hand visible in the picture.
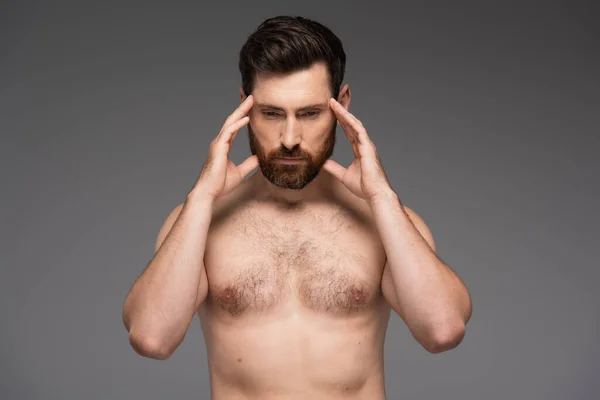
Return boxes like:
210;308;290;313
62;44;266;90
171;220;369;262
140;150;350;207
123;193;213;359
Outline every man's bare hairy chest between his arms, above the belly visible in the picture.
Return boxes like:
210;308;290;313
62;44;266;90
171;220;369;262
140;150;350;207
204;202;385;315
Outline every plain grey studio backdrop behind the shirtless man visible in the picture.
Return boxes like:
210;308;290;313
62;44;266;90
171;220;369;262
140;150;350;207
0;1;600;400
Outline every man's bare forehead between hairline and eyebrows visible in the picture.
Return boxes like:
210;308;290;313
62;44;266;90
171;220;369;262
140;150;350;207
252;63;331;109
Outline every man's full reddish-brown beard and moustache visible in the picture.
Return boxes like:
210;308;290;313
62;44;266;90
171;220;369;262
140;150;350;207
247;122;336;190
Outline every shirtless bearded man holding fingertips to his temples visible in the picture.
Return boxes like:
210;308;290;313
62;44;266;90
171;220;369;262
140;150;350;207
123;17;471;400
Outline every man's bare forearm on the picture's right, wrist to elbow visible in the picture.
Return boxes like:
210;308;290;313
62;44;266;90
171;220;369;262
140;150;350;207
371;192;470;342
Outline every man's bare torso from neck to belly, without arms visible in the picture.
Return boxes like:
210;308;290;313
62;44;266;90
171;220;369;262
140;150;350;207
198;173;390;400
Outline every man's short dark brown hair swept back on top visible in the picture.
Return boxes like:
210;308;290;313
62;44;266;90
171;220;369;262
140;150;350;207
238;15;346;98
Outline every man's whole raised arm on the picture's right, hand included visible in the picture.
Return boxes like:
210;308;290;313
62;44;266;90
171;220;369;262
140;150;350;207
323;98;471;353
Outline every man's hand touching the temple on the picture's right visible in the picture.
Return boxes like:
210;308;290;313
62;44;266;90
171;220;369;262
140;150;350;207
323;98;392;202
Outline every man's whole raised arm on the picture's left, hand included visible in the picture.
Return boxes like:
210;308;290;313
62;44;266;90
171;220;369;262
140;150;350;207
123;96;258;359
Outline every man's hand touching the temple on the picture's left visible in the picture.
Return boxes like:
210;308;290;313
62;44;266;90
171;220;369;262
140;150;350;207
192;95;258;199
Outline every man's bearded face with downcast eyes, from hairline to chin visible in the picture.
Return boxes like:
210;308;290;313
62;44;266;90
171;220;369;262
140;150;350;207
248;63;346;190
